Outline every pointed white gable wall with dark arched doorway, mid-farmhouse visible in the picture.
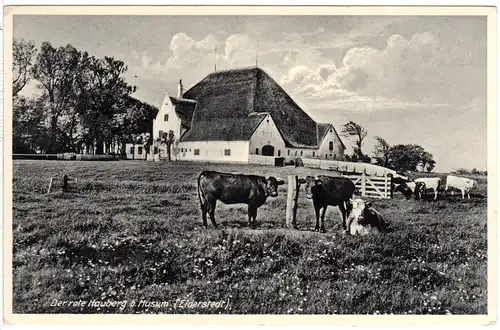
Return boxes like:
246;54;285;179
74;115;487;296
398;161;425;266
250;115;285;157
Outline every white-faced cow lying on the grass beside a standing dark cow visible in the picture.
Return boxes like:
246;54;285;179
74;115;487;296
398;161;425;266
347;199;390;236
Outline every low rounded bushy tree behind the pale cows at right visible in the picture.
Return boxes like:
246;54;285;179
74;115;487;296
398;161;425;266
388;144;436;172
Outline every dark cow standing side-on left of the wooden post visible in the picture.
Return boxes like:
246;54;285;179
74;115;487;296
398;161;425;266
198;171;285;227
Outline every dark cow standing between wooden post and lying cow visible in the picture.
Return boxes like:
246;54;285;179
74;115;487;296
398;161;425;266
305;175;356;233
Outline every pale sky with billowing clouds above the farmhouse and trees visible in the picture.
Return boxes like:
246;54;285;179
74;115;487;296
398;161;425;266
14;16;487;172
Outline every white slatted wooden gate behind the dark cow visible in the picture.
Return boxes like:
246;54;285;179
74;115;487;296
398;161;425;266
343;173;392;198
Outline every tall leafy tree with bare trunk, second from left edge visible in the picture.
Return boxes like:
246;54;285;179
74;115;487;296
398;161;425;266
32;42;80;153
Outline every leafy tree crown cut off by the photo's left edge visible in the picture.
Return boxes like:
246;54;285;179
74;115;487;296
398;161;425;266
12;38;36;97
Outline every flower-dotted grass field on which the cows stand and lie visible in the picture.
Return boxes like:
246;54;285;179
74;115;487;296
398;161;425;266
12;160;487;314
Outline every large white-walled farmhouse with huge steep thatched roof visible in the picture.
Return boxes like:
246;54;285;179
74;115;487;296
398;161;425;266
153;67;345;163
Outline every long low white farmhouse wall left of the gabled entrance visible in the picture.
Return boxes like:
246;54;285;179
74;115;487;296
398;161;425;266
177;141;249;163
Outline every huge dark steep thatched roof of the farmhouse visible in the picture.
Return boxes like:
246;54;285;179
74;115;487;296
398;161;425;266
181;67;344;148
